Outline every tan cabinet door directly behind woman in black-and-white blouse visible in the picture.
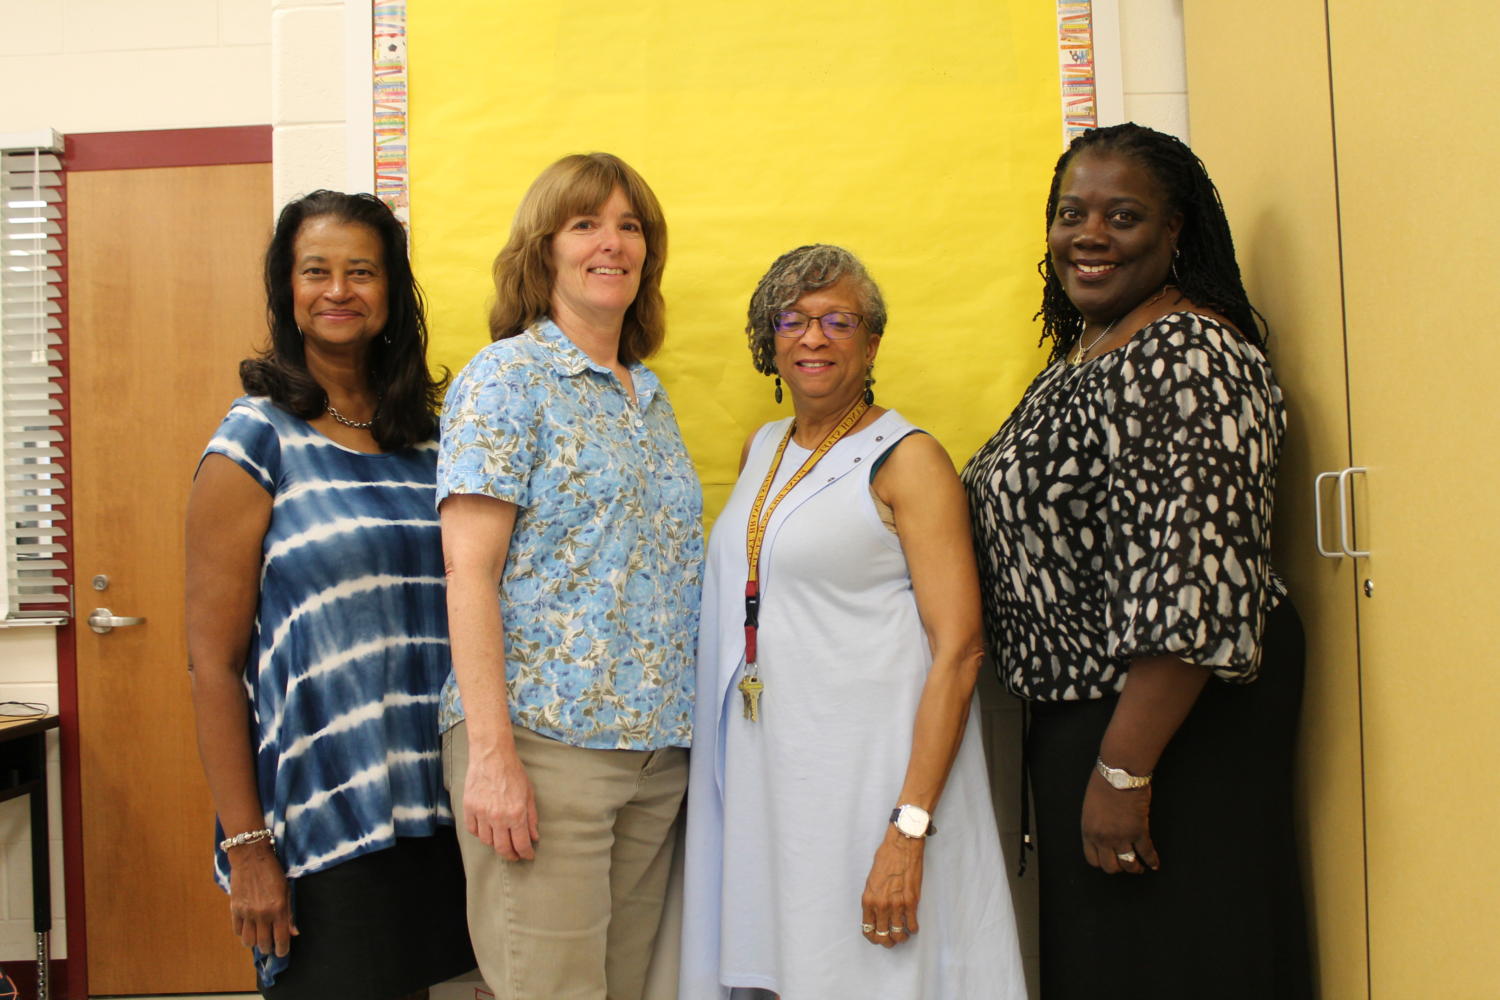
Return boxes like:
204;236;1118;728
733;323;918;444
1184;0;1370;1000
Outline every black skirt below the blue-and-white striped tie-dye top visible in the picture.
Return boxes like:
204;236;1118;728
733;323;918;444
261;826;476;1000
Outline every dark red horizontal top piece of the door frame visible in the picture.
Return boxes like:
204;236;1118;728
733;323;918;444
63;124;272;174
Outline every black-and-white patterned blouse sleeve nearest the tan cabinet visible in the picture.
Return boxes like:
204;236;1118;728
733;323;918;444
1106;313;1284;682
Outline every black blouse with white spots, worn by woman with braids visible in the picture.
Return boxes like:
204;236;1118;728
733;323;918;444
963;313;1286;702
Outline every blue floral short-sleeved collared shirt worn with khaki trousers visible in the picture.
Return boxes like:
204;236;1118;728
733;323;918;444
438;319;704;750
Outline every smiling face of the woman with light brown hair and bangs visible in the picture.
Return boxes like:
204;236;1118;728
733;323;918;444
552;187;647;330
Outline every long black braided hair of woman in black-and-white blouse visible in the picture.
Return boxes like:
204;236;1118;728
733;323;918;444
1034;121;1266;361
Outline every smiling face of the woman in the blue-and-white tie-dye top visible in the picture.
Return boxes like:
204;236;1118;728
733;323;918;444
291;216;389;355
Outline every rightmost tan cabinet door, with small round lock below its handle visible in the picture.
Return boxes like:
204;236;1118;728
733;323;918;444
1328;0;1500;1000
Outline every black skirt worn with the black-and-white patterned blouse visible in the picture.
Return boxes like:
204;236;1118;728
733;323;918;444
1028;600;1313;1000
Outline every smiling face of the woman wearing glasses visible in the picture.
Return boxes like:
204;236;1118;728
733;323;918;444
776;277;881;408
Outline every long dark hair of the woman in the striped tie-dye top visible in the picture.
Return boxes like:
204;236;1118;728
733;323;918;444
240;190;449;451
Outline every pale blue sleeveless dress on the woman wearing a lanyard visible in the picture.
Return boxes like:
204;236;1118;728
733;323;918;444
680;411;1026;1000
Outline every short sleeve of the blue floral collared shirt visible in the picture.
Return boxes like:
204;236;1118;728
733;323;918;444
438;342;546;507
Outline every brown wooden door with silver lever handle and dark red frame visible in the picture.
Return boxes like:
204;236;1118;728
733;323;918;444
68;163;272;994
